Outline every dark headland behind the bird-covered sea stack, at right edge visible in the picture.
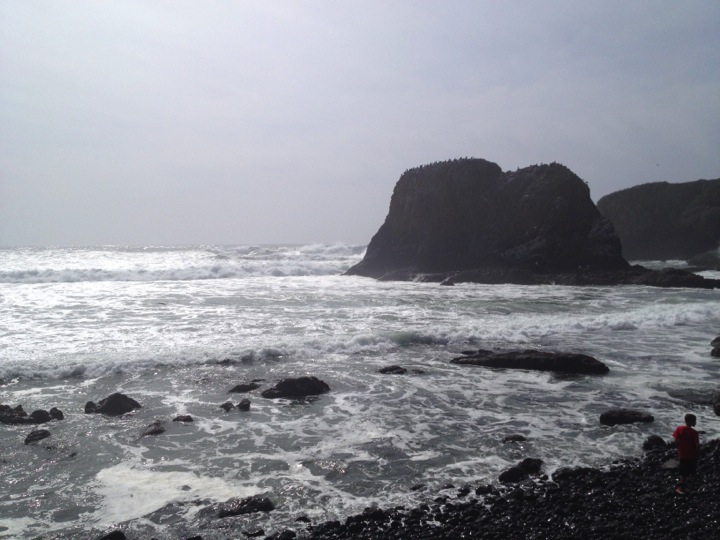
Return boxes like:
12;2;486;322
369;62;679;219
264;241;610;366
598;178;720;260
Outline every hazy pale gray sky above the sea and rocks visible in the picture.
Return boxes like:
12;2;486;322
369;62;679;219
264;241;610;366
0;0;720;245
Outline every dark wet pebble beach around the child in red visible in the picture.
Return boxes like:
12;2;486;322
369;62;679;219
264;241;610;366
298;441;720;540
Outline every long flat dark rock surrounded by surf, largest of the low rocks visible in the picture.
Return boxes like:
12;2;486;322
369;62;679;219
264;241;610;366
450;349;610;375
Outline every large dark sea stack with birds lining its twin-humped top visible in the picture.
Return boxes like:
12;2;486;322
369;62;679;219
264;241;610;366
348;159;627;277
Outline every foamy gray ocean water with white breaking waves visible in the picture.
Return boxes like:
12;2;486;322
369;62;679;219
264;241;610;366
0;244;720;539
